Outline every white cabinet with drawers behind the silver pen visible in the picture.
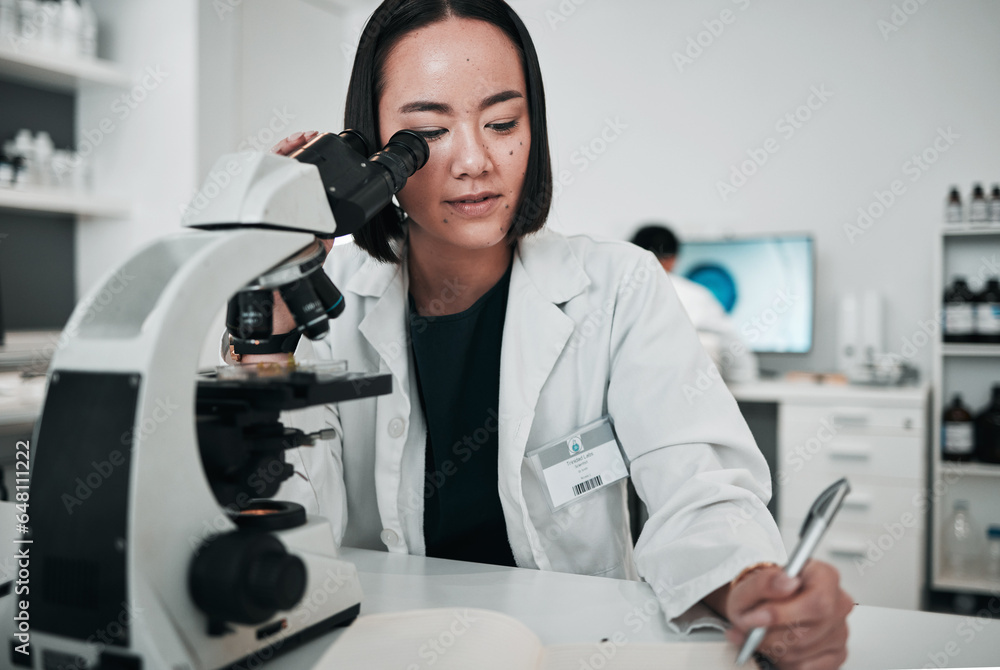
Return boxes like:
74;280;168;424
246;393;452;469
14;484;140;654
732;382;929;609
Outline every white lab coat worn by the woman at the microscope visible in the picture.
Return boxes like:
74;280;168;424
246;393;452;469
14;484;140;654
276;231;784;630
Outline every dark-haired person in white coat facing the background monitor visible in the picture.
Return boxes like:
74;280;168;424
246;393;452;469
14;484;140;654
632;224;757;382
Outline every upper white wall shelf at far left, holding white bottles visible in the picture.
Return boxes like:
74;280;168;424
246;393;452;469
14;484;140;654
0;45;132;92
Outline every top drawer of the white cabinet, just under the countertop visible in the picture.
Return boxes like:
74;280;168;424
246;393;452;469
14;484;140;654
781;403;925;436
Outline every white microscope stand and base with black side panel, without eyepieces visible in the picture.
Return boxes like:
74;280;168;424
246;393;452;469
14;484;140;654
0;129;426;670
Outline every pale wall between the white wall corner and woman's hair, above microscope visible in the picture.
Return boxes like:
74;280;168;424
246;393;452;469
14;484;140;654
198;0;347;181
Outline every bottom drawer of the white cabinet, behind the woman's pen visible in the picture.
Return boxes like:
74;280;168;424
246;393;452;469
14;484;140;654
781;519;924;610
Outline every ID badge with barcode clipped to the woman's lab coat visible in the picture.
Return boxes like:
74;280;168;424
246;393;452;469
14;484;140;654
525;416;628;511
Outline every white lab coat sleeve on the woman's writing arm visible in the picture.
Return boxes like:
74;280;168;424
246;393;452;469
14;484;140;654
608;255;785;632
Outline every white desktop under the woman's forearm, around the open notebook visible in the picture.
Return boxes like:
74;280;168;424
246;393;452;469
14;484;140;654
265;549;1000;670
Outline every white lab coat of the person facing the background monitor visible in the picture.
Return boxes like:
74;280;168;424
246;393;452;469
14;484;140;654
669;272;757;383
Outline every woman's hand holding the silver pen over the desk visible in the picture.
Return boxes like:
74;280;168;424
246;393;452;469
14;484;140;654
725;560;854;670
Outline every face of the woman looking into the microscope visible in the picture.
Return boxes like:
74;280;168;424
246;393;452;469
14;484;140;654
378;18;531;255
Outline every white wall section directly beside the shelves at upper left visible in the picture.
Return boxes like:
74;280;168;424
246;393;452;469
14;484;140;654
76;0;198;296
